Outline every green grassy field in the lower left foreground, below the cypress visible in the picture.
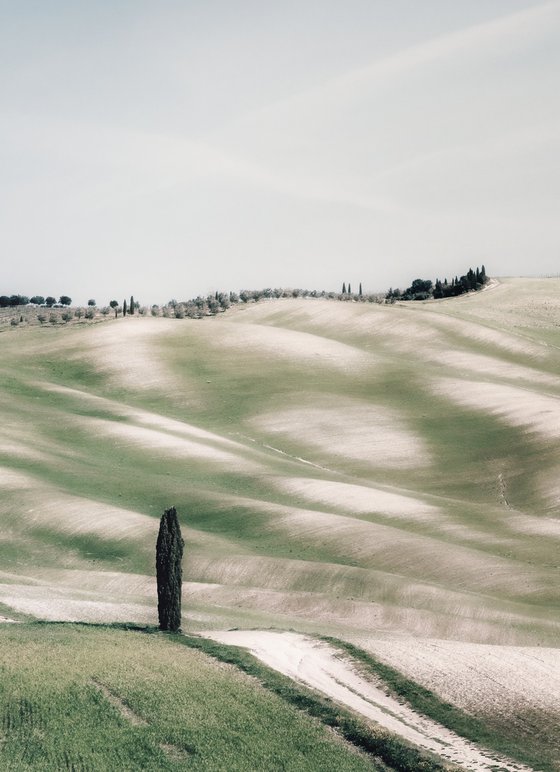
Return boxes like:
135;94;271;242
0;624;378;772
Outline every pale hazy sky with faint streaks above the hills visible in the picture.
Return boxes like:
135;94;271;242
0;0;560;303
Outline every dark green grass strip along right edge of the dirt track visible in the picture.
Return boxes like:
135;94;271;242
323;636;558;772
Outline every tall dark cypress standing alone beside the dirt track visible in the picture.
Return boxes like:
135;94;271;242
156;507;185;632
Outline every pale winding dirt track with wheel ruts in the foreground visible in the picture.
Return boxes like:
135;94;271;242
205;630;529;772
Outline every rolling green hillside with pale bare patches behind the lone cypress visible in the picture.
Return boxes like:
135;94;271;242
0;280;560;764
